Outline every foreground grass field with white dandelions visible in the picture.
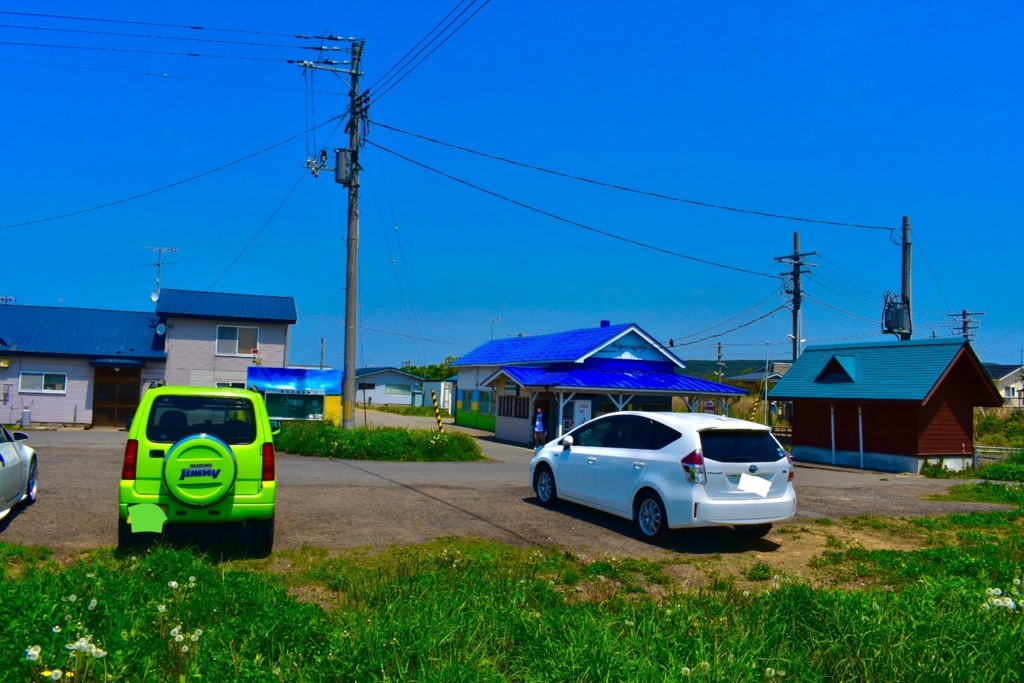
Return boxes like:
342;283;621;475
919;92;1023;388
0;484;1024;682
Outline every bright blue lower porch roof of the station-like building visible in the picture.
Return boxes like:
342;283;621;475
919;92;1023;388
502;366;746;396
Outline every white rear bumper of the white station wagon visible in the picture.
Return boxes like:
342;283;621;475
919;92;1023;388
665;484;797;528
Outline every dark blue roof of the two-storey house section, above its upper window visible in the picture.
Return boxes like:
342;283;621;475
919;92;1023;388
157;290;298;325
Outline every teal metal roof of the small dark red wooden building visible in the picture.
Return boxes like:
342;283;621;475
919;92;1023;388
769;337;980;401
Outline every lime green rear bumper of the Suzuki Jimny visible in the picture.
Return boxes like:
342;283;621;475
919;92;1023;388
118;479;278;524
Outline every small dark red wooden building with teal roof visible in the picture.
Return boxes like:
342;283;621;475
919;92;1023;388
769;337;1002;472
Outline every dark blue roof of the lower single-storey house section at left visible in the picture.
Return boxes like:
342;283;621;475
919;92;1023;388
0;305;167;360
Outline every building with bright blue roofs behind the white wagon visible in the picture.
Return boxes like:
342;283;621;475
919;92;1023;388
453;321;746;443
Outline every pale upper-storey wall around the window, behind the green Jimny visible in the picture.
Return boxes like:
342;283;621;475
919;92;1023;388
165;317;288;387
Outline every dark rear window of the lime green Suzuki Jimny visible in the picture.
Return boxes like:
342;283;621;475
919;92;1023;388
145;396;256;445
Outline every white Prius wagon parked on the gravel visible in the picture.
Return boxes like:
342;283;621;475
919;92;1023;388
529;413;797;542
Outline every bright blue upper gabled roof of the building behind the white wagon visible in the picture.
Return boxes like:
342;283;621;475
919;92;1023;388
453;324;686;368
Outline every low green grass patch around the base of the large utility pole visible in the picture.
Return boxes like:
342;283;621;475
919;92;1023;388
274;422;486;462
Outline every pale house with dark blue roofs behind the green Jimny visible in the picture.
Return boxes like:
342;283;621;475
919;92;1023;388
0;290;297;427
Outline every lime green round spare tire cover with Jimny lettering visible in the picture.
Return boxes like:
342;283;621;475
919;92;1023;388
164;434;239;507
